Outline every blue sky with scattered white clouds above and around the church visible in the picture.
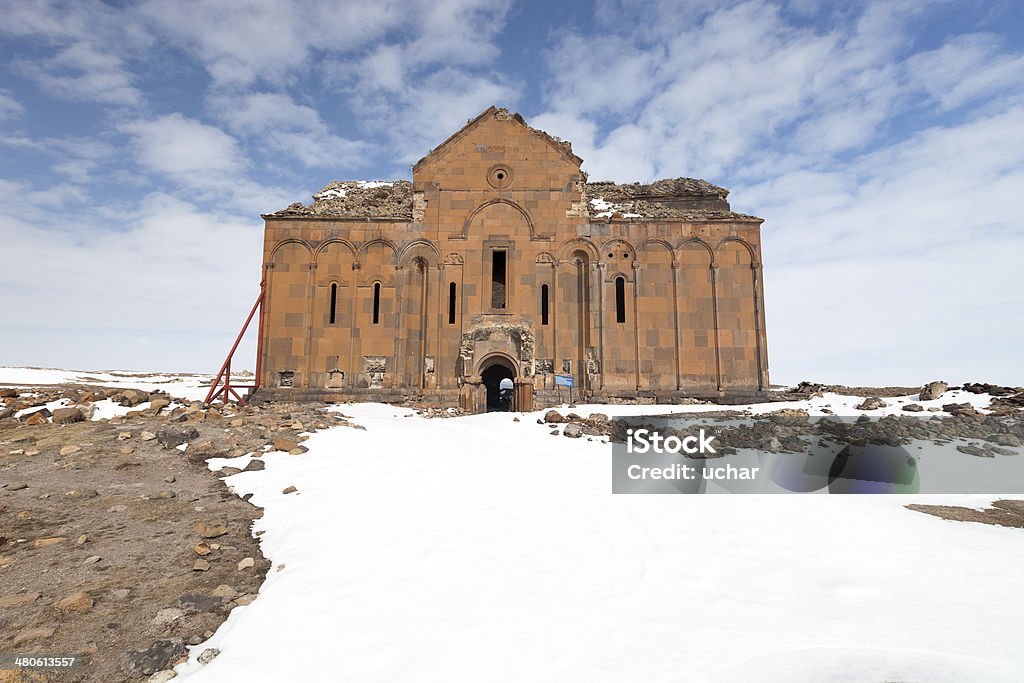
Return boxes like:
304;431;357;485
0;0;1024;385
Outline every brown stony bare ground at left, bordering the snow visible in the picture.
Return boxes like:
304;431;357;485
0;386;354;682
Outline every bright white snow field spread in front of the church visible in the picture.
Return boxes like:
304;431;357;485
178;401;1024;683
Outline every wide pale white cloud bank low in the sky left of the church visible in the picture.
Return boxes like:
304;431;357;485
0;191;262;372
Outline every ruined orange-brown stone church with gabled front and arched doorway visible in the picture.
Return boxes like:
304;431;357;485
258;106;768;412
